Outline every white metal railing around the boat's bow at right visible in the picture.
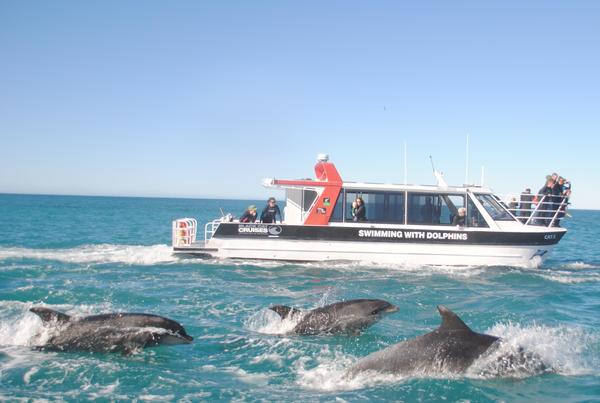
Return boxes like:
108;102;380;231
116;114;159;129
503;193;571;227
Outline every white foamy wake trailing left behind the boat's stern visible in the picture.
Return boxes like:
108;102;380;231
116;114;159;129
0;244;178;265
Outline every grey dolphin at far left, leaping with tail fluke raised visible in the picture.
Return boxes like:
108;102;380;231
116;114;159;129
30;307;193;355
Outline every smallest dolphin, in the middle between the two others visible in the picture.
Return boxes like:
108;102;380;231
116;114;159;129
269;299;398;335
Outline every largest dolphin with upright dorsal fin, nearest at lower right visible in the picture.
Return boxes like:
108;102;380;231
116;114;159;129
345;305;548;378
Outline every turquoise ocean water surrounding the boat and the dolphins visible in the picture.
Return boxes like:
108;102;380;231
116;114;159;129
0;195;600;402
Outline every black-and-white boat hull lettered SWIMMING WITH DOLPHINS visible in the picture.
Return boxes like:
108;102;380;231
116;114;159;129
175;223;564;267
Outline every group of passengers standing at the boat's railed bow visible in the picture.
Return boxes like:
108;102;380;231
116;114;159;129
509;173;571;227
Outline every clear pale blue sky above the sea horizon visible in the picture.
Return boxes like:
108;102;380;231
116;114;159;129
0;1;600;208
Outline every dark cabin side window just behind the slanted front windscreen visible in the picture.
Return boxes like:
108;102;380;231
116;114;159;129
407;193;465;225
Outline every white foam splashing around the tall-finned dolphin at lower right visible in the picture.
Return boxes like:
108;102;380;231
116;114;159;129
294;323;600;391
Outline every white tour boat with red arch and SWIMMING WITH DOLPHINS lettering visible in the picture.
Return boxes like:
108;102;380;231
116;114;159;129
173;155;568;267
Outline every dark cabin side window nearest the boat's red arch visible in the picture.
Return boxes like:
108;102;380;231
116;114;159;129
336;190;405;224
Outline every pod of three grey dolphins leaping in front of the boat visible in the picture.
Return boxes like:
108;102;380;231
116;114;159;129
30;299;551;379
